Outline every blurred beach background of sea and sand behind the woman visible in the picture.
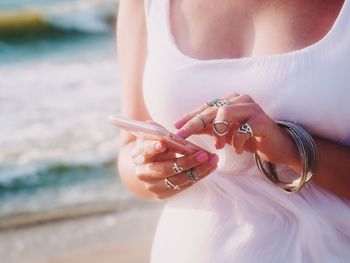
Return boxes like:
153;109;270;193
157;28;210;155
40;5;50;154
0;0;160;263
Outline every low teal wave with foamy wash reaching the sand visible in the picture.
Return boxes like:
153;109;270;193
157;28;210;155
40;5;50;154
0;159;135;231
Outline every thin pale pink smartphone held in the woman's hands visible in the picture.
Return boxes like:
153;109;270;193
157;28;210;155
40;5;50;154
108;116;207;154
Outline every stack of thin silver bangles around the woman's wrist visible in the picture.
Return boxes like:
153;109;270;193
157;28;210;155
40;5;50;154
254;121;317;193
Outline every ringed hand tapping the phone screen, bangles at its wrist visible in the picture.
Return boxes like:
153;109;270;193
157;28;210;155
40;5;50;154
175;93;299;167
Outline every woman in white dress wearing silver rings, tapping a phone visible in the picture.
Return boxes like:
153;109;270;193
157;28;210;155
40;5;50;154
118;0;350;263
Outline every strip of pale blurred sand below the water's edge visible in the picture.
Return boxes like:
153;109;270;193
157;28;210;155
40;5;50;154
0;203;162;263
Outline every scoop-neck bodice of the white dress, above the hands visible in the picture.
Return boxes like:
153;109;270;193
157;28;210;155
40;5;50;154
143;0;350;144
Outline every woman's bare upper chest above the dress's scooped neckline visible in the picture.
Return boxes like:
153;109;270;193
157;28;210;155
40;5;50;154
169;0;344;59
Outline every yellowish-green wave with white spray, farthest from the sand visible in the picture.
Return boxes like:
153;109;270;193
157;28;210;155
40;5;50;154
0;0;117;39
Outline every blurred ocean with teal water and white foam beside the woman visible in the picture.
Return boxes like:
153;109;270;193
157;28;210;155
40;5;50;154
0;0;134;229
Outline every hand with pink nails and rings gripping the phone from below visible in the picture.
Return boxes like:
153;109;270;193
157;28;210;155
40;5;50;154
131;139;218;199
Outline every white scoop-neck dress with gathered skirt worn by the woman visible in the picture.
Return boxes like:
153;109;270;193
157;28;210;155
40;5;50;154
143;0;350;263
